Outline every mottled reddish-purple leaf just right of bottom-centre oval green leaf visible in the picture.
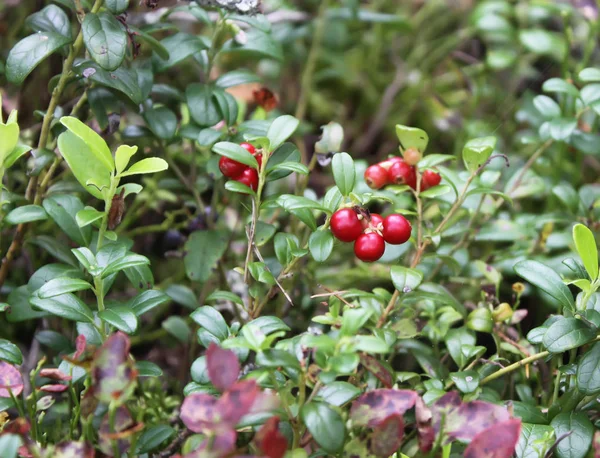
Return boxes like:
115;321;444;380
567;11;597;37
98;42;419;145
350;388;418;427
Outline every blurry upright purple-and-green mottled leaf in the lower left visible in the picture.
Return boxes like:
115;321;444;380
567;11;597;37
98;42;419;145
92;331;137;404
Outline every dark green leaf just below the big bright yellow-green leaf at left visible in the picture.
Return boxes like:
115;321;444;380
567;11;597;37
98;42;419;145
43;194;92;246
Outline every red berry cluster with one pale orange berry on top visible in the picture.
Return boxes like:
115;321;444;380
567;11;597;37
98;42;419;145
365;148;442;191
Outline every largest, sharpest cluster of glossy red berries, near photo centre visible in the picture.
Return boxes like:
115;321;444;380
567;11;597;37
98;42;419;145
330;207;412;262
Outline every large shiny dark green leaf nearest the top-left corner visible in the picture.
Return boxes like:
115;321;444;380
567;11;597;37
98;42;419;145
6;32;71;84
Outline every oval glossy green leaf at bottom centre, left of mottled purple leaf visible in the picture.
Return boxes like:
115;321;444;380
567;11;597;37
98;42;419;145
301;401;346;454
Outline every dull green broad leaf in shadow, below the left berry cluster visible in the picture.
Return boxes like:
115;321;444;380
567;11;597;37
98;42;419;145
183;230;229;282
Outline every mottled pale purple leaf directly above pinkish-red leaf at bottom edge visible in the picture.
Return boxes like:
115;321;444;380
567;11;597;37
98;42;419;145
444;401;510;440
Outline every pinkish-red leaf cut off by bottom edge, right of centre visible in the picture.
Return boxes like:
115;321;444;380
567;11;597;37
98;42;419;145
464;418;521;458
